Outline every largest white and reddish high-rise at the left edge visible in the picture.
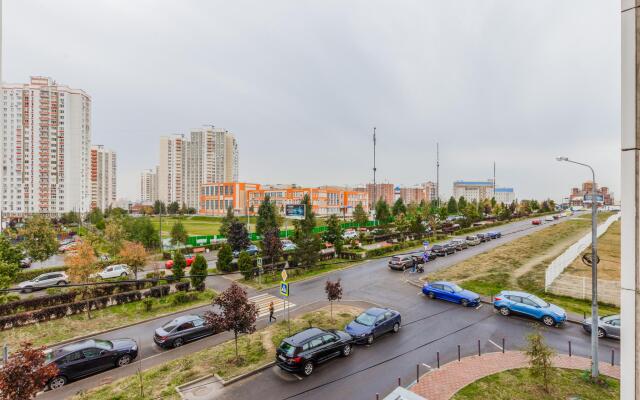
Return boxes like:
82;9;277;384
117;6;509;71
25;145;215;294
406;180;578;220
0;77;91;216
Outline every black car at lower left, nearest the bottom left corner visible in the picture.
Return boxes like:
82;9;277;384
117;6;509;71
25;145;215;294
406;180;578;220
46;339;138;389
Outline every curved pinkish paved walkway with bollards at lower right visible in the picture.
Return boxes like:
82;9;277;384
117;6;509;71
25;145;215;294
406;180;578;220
411;351;620;400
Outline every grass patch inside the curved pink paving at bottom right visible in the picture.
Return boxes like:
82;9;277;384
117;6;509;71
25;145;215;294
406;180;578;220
452;368;620;400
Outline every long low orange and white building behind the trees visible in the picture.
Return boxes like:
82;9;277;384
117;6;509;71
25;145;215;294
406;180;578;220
199;182;369;217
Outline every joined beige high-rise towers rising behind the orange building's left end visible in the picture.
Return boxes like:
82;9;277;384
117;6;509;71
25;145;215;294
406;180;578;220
158;126;239;209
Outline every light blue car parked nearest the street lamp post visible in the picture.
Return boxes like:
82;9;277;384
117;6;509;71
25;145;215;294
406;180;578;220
493;290;567;326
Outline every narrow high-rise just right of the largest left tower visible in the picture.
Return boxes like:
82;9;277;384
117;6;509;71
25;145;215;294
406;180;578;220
90;145;117;210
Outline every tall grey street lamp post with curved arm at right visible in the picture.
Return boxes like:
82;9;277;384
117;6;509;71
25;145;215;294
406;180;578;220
556;157;598;379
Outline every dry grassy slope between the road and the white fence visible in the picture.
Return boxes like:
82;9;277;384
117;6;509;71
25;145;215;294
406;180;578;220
425;213;619;314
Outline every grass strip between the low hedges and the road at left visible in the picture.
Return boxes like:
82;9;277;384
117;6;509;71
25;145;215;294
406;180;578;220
0;290;214;348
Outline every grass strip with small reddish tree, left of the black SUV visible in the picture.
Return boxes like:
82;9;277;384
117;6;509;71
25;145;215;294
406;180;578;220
72;306;360;400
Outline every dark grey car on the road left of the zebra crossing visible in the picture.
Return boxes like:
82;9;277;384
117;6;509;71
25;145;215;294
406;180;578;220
153;315;217;348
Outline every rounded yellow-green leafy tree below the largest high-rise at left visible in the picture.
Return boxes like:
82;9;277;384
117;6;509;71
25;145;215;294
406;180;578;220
19;215;58;261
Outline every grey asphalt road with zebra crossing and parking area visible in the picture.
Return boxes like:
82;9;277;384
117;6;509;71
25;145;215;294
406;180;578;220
39;212;619;400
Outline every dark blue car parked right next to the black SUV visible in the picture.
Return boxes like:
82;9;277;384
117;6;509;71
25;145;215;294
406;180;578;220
344;307;402;344
